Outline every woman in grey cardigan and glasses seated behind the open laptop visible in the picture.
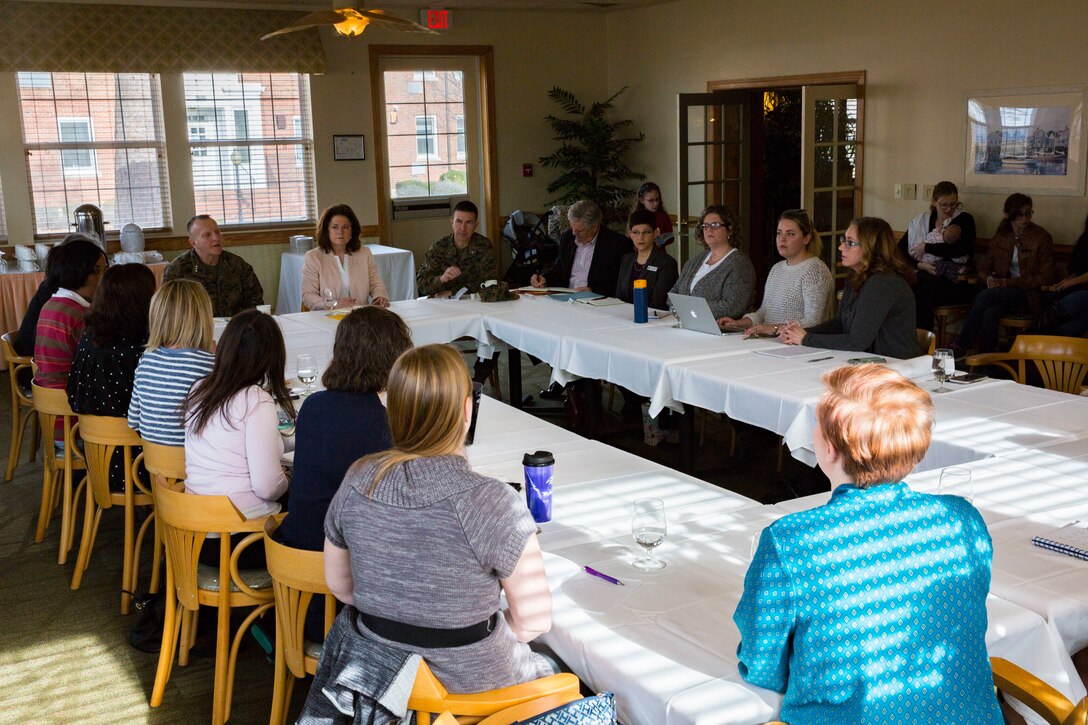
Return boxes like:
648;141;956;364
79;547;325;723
670;204;755;319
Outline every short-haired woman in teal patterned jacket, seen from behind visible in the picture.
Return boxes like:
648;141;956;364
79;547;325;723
733;365;1003;725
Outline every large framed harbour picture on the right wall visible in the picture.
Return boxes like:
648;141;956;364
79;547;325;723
964;86;1086;196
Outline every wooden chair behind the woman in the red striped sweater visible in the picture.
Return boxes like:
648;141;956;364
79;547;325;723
32;383;87;564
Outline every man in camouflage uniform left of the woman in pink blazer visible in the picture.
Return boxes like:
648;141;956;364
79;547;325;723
162;214;264;317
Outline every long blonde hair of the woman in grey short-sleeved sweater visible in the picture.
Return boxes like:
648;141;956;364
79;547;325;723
356;345;472;494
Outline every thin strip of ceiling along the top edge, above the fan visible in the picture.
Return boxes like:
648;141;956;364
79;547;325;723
10;0;675;12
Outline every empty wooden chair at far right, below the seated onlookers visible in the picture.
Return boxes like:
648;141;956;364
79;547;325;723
966;335;1088;395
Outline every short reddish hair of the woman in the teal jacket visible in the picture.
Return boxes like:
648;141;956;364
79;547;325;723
816;364;934;488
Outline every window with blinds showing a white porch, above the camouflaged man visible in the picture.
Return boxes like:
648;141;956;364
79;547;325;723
185;73;317;224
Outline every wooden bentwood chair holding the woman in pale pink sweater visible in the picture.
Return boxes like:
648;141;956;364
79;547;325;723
151;482;273;725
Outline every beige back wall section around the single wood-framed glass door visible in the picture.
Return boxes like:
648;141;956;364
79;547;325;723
310;11;607;246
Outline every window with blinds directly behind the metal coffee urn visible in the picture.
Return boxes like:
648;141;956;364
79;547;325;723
17;73;170;235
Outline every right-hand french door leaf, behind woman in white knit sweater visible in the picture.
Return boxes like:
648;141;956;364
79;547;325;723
801;84;863;278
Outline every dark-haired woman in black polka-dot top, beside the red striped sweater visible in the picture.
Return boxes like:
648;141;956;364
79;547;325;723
67;265;154;490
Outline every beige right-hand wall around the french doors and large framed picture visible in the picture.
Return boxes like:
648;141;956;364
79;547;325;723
606;0;1088;244
